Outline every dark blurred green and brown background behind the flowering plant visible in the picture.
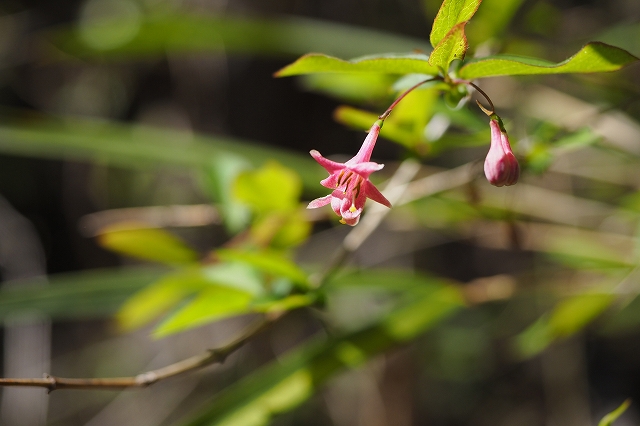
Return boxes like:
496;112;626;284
0;0;640;426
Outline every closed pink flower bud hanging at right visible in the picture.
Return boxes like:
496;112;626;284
484;118;520;186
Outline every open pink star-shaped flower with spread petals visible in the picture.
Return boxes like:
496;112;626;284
307;120;391;226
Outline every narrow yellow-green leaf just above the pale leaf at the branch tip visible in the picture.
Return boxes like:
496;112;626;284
216;249;309;287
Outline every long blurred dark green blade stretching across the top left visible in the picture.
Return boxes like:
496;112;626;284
44;14;430;59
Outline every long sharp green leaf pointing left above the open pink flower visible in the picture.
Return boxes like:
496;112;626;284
275;53;438;77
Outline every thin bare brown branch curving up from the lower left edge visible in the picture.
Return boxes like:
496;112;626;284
0;312;283;392
